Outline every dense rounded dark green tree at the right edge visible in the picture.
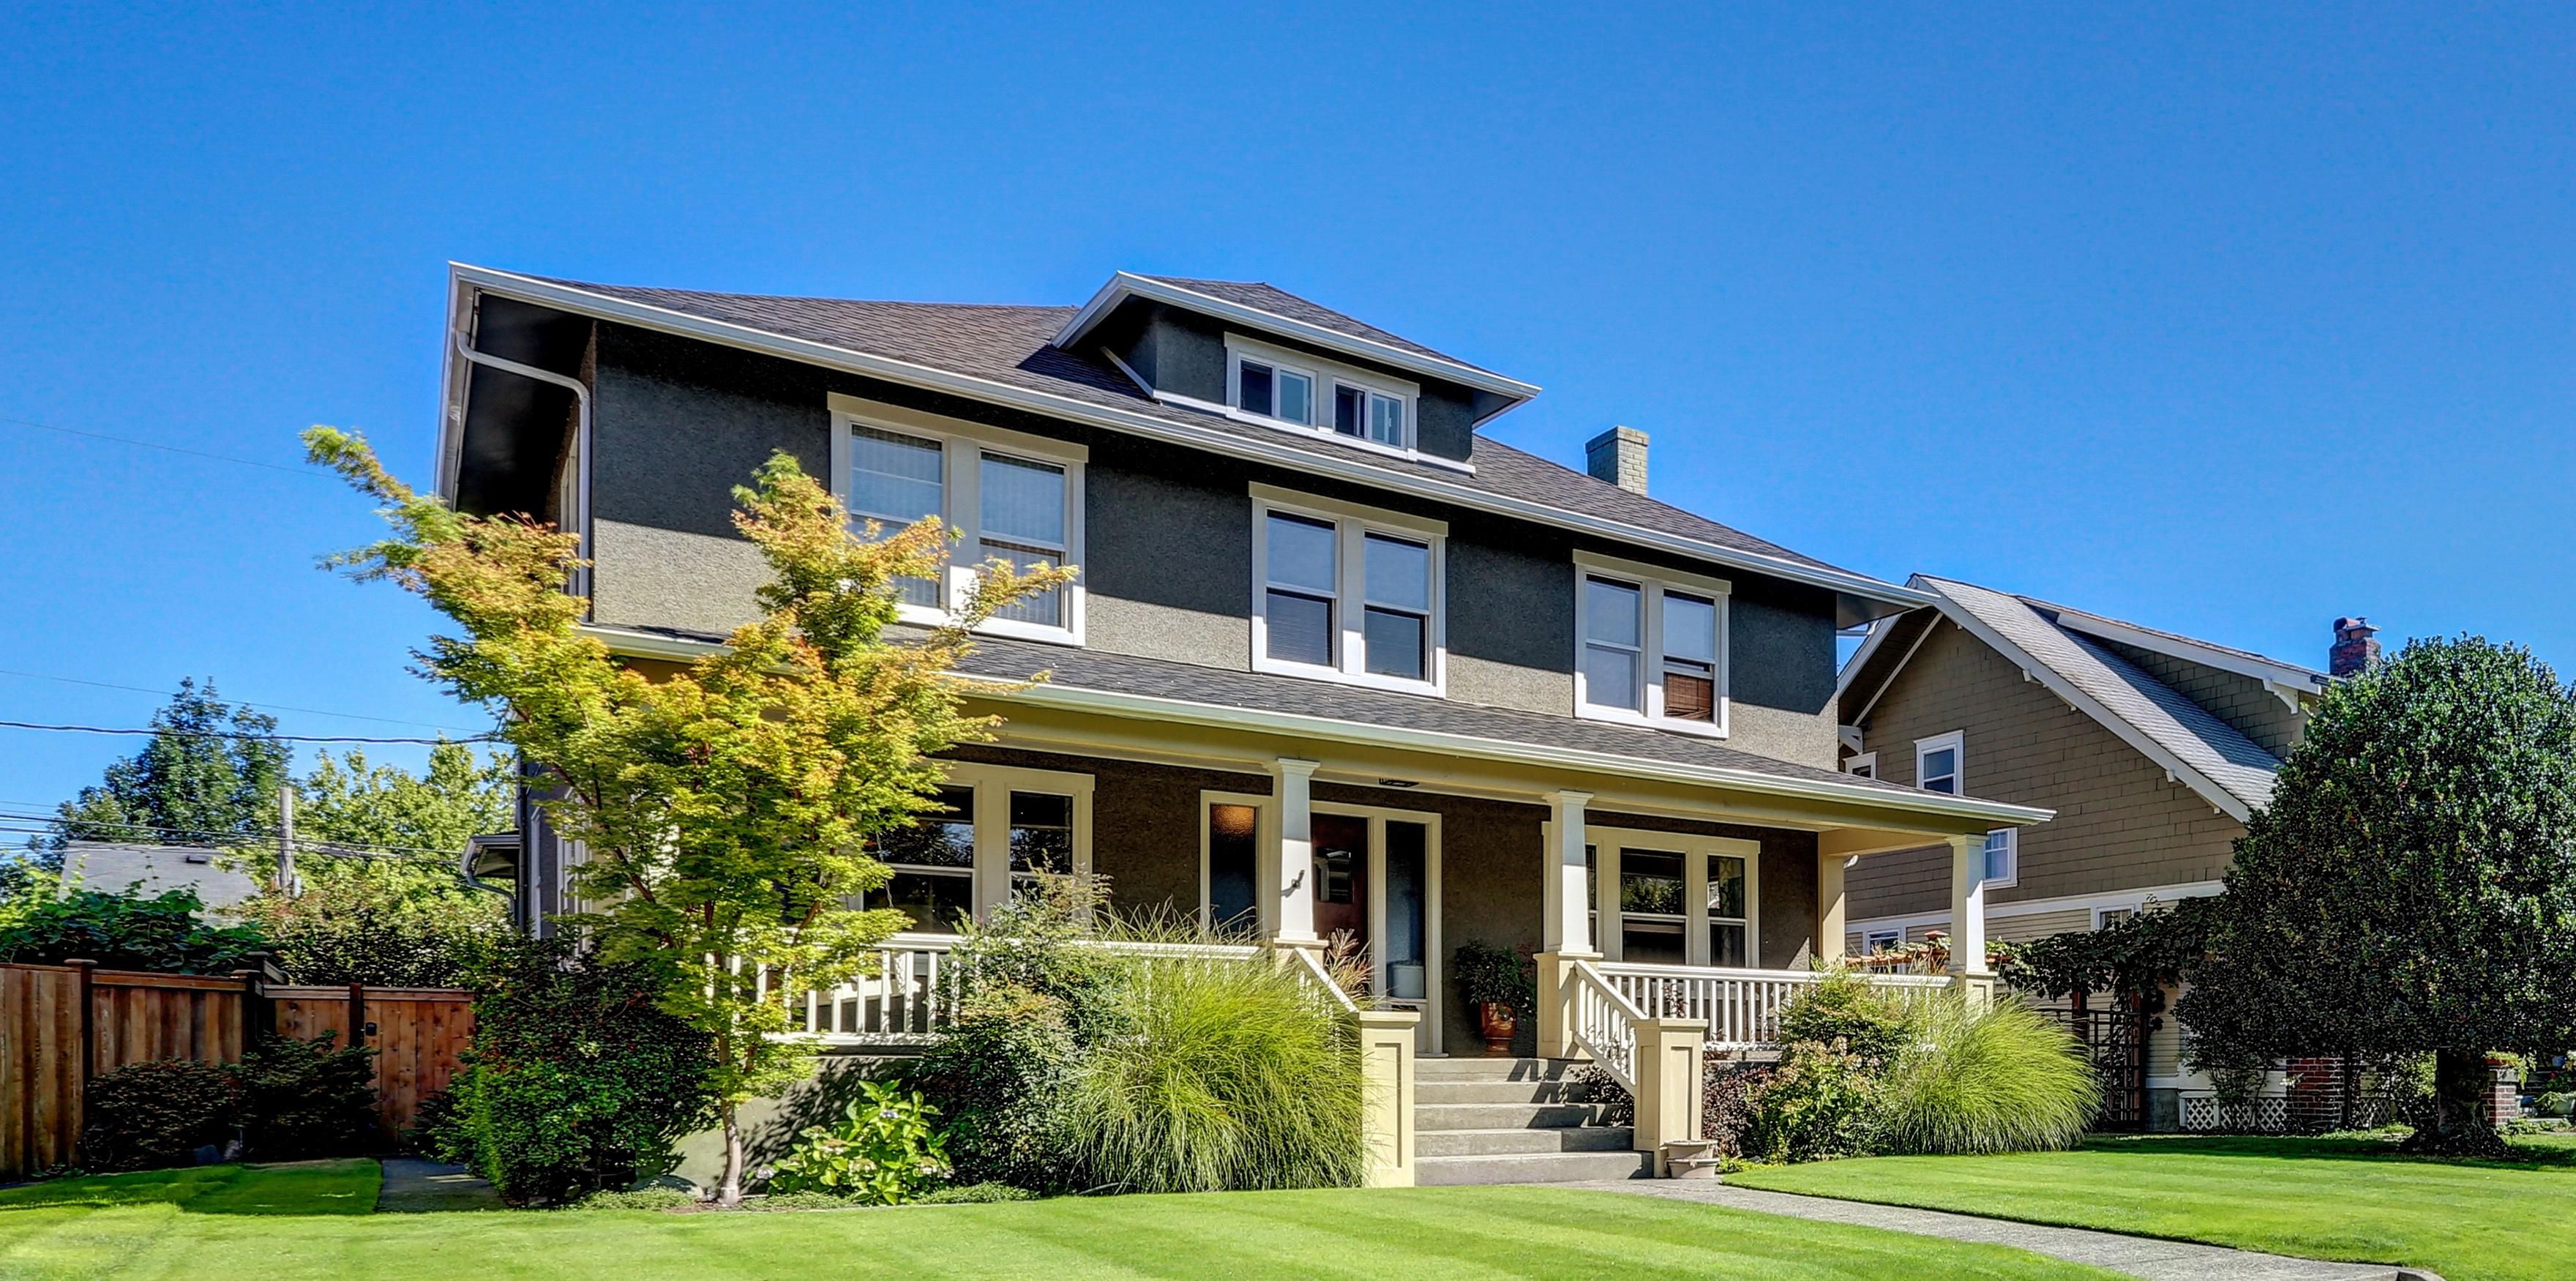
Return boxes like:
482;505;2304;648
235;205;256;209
2179;637;2576;1154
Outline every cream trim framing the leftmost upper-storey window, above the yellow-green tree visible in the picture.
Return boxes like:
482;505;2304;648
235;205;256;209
827;392;1090;644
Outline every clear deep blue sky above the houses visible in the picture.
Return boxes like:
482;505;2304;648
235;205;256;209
0;3;2576;807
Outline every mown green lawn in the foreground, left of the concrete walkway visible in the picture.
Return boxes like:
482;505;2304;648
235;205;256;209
0;1160;2110;1281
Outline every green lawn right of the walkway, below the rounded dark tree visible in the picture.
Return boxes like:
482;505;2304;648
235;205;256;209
1726;1134;2576;1281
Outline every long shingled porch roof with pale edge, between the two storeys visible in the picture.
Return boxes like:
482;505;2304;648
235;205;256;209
595;619;2053;825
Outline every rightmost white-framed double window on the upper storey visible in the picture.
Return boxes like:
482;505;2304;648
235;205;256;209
1574;552;1726;735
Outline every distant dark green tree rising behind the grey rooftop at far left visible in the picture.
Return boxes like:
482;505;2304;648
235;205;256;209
46;678;293;869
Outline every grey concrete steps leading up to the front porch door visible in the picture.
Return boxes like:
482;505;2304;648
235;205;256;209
1414;1059;1654;1186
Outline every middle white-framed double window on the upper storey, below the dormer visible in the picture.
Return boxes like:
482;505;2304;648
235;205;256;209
1252;485;1448;693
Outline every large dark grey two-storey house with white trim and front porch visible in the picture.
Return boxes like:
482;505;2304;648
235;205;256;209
438;266;2048;1181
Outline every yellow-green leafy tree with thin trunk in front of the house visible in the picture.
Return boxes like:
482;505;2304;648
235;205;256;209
304;428;1071;1203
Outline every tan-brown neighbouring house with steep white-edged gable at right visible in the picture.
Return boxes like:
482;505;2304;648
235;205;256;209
1839;575;2378;1124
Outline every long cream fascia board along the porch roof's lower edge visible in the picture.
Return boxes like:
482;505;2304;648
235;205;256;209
583;627;2058;827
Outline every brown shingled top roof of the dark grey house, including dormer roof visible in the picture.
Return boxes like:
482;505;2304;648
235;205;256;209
512;276;1876;583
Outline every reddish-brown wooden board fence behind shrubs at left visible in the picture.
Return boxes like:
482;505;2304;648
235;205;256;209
0;961;474;1181
